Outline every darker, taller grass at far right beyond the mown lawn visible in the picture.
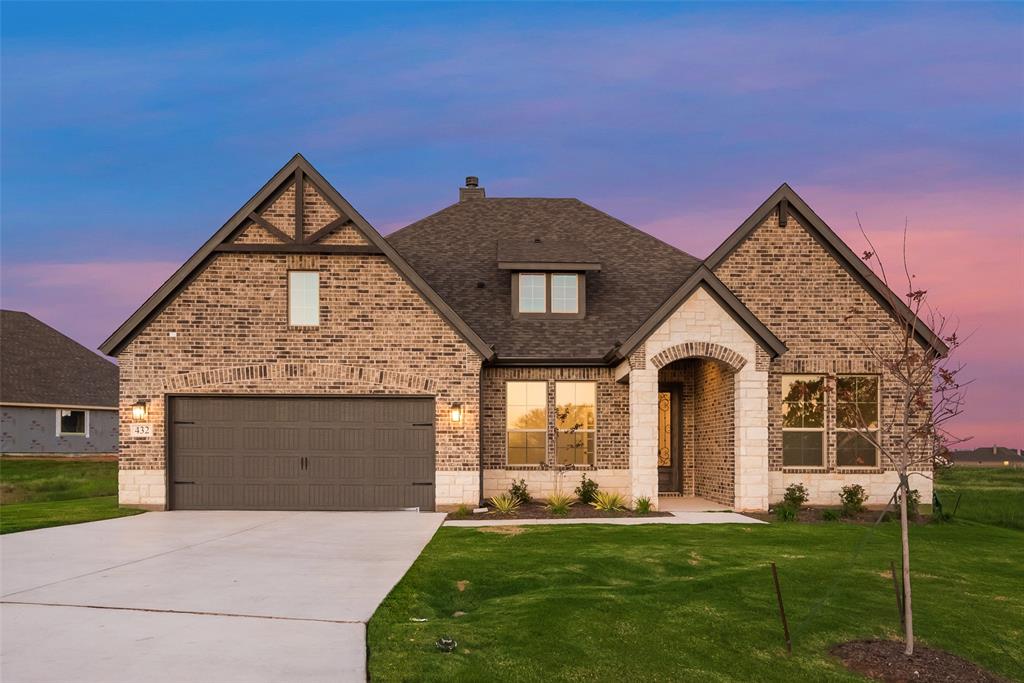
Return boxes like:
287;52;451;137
936;468;1024;530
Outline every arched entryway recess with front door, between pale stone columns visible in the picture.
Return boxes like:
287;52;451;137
651;342;745;506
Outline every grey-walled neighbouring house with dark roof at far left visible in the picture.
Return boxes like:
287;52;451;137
0;310;118;456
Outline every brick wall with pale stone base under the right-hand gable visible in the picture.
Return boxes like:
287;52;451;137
715;210;932;505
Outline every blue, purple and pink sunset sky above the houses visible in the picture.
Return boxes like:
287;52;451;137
0;2;1024;447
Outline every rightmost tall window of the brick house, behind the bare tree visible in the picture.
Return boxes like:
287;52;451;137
836;375;879;467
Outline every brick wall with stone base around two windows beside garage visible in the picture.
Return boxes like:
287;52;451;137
481;368;630;498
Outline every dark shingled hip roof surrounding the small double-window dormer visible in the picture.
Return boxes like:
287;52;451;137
387;198;700;359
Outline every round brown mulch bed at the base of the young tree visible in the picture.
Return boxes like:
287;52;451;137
829;640;1007;683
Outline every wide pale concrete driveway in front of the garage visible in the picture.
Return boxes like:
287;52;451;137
0;512;443;683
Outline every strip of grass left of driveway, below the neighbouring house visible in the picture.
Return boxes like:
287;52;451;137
0;458;140;533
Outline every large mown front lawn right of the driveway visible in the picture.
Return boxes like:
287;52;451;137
368;471;1024;681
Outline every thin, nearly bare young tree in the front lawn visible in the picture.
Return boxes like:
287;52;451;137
837;216;968;655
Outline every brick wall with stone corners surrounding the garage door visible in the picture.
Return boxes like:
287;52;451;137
118;181;481;507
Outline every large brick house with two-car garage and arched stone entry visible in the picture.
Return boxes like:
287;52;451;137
101;156;946;510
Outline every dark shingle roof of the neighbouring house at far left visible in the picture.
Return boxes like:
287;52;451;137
0;310;118;408
